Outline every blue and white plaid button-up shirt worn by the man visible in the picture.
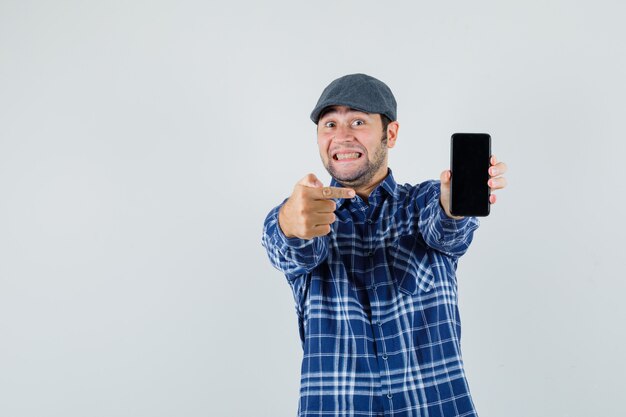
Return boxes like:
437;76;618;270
262;170;478;417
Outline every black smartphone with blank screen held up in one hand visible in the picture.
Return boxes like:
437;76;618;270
450;133;491;217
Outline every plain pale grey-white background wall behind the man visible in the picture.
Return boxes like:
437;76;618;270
0;0;626;417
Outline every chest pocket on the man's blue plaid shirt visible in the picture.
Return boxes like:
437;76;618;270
391;235;435;295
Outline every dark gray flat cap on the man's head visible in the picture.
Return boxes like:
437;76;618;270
311;74;397;124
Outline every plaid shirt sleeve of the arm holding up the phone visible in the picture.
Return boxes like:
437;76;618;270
417;181;479;257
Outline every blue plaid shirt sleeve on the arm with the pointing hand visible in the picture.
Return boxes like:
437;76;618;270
261;202;328;279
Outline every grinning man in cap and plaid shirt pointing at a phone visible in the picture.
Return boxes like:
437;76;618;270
262;74;506;417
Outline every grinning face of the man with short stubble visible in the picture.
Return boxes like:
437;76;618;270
317;106;395;187
